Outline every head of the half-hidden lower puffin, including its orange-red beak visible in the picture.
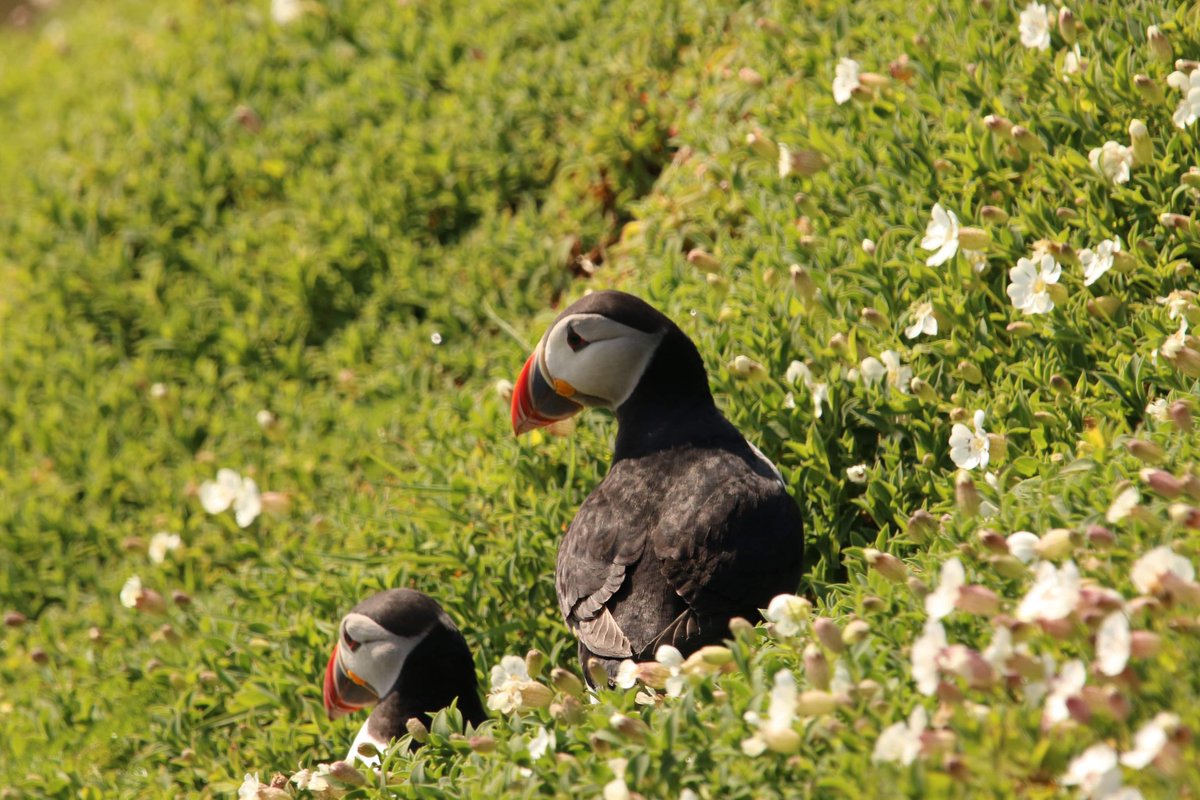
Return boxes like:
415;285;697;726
324;589;457;720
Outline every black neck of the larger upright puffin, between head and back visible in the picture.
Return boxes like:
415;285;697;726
613;327;742;463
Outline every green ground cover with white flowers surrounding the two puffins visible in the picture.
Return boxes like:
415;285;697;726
0;0;1200;800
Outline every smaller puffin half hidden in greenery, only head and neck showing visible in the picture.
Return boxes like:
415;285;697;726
323;589;487;766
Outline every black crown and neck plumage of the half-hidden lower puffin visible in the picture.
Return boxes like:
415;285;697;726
353;589;487;741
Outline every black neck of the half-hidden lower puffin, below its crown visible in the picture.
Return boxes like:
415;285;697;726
365;625;487;742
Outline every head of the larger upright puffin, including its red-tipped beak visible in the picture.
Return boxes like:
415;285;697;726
512;291;710;434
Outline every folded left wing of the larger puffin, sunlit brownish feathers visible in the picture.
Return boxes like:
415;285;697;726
554;482;646;658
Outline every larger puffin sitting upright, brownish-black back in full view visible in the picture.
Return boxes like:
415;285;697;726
512;290;804;682
